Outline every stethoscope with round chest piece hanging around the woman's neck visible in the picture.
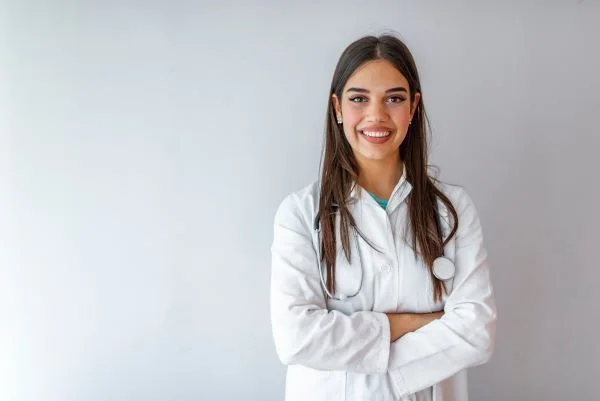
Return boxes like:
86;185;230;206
313;204;456;301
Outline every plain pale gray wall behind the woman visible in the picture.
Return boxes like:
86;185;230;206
0;0;600;401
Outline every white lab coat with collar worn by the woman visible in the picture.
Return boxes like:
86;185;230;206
271;169;496;401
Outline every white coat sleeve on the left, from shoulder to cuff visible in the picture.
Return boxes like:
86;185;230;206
271;195;390;374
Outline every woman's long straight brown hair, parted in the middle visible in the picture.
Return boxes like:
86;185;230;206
319;35;458;301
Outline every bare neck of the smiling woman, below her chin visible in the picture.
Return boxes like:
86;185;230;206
358;158;404;199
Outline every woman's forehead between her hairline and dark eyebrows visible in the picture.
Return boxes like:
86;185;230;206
344;60;408;92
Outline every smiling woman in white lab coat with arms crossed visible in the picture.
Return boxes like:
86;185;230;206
271;35;496;401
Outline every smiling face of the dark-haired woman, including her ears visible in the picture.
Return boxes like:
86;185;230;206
332;60;420;165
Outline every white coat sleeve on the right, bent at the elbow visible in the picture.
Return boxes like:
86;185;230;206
388;189;496;398
